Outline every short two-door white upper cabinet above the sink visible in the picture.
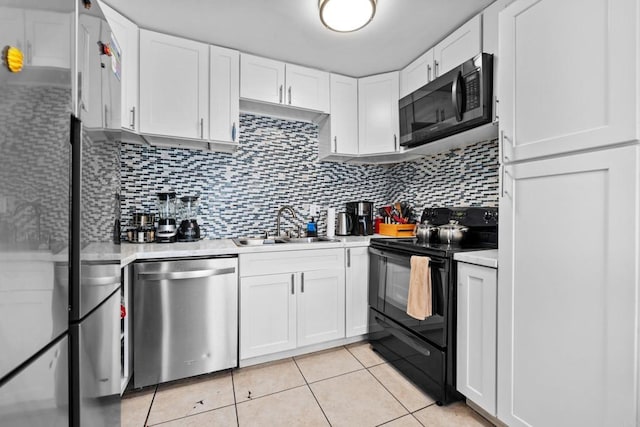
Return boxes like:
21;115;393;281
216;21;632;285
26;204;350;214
240;54;329;112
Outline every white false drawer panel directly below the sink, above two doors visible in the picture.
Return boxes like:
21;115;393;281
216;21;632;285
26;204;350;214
239;248;344;277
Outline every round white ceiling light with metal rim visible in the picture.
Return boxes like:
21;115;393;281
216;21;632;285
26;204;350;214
318;0;376;33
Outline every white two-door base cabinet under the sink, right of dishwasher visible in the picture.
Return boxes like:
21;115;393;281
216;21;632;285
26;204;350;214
240;249;345;360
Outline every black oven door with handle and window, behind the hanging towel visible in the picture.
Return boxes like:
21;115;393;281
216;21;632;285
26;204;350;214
369;248;449;348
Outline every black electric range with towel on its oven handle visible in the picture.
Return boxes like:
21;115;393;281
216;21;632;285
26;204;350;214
369;207;498;404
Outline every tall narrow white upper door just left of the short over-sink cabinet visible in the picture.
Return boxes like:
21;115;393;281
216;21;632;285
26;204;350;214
209;46;240;142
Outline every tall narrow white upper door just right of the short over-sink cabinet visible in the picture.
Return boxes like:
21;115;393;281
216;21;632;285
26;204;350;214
329;74;358;154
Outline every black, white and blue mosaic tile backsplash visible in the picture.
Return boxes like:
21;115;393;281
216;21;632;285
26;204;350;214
120;114;498;238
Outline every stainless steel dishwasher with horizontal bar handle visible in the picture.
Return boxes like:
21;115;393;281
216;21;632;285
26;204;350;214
133;257;238;388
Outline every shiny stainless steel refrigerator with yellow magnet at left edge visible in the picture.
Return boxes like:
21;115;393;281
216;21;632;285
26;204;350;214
0;0;121;427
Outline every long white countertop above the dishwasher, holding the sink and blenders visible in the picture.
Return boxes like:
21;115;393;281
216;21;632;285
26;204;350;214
120;234;391;266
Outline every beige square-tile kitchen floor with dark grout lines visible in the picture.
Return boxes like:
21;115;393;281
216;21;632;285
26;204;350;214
122;343;491;427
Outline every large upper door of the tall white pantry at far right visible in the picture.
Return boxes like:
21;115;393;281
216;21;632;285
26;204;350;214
498;0;639;162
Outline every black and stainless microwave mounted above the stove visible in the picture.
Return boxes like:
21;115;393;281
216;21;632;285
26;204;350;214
399;53;493;148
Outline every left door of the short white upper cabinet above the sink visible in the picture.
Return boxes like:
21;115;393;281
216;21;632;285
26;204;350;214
240;53;285;104
